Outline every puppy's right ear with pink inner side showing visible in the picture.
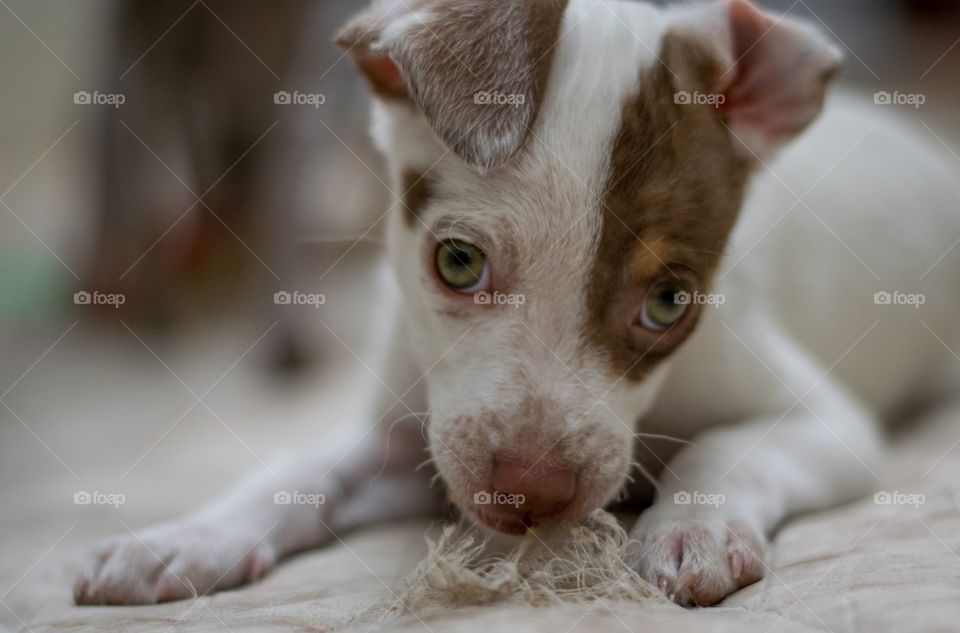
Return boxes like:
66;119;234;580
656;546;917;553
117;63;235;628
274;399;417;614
664;0;843;159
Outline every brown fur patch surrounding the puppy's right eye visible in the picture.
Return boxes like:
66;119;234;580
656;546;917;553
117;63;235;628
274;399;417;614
588;32;751;380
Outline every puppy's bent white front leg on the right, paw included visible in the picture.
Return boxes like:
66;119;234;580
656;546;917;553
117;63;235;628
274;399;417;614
630;329;882;605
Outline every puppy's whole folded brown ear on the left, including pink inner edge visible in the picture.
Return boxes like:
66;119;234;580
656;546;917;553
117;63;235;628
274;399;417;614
337;0;567;169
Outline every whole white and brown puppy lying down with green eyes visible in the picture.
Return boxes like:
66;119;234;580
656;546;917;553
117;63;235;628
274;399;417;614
76;0;960;605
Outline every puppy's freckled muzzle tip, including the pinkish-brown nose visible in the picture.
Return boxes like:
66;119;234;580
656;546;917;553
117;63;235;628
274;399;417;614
430;404;632;534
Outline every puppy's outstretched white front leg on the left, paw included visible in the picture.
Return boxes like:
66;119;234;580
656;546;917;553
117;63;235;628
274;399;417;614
74;314;442;604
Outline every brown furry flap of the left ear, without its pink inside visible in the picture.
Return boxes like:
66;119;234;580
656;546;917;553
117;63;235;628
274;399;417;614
393;0;566;168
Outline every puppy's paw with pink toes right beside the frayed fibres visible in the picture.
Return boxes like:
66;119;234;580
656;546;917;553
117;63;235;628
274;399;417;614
629;517;766;606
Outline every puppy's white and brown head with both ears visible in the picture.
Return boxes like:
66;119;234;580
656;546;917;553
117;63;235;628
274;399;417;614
339;0;839;533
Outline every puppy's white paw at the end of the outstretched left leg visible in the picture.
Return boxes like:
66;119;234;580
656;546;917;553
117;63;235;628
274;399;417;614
73;523;276;605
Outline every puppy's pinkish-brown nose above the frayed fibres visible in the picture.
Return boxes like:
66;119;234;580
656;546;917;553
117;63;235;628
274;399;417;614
490;459;577;526
